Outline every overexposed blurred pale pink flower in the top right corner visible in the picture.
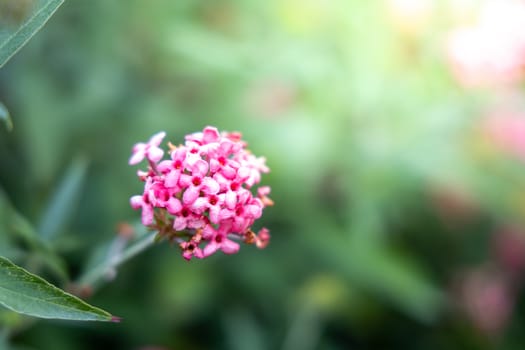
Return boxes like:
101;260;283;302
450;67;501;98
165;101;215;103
447;0;525;86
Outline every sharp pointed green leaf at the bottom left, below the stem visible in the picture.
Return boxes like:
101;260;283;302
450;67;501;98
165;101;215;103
0;257;119;322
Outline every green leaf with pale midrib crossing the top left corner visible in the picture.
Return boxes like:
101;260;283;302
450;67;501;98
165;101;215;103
0;0;64;68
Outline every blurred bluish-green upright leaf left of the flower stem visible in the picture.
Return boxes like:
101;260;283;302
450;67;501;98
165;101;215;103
38;157;88;240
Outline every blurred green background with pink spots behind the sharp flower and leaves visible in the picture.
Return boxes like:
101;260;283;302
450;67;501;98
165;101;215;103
0;0;525;350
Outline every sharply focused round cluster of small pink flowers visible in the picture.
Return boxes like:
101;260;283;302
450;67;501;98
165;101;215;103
129;126;273;260
